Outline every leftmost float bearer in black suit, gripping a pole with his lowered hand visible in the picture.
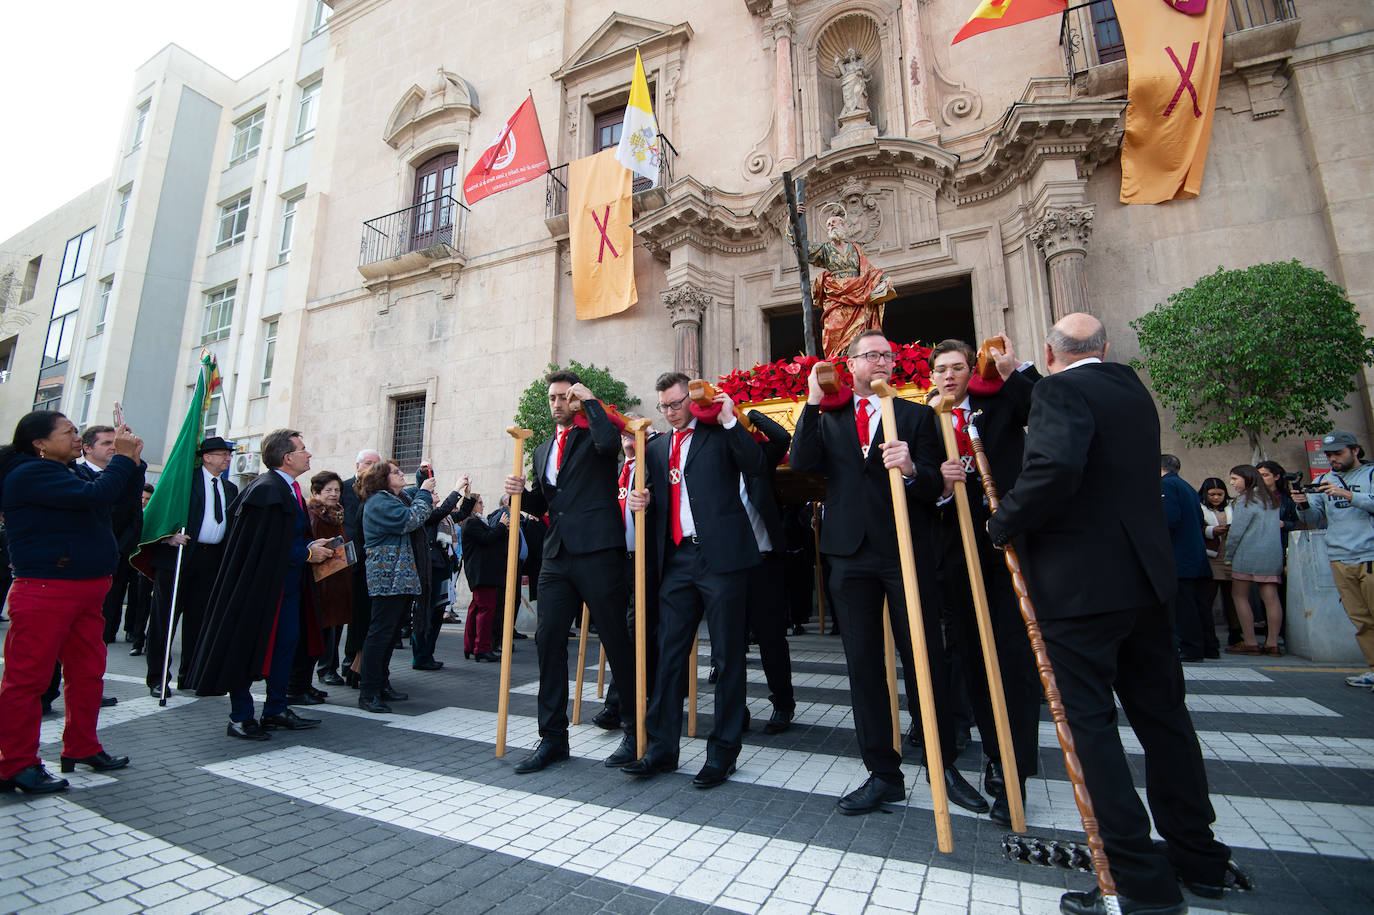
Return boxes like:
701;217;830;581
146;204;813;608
506;371;638;775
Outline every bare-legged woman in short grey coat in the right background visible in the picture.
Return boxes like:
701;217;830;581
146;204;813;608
1226;464;1283;657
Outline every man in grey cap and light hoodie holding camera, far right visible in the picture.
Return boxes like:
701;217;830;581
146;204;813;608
1293;429;1374;690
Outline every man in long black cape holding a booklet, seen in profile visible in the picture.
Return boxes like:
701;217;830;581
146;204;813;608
188;429;333;741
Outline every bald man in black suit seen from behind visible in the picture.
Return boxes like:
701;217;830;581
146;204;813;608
988;313;1230;915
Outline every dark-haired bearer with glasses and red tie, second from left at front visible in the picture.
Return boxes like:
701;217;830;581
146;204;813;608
621;372;768;789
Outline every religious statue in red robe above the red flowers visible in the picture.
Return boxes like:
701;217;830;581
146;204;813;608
787;203;897;360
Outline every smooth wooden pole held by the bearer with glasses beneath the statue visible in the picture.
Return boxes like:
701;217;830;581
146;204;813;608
872;379;954;853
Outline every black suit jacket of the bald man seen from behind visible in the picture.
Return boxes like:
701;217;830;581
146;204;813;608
989;363;1176;620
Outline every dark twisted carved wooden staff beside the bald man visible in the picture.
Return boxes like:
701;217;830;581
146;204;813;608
969;414;1117;890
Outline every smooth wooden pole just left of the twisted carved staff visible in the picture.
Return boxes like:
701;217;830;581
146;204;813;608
926;387;1026;833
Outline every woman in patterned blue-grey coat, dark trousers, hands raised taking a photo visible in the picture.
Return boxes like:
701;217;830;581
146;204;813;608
357;460;434;713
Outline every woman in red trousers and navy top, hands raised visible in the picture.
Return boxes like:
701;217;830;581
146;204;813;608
0;409;146;794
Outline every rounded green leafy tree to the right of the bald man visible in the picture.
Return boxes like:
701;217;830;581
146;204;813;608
1131;260;1374;460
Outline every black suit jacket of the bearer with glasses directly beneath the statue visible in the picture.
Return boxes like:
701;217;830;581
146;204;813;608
791;400;944;556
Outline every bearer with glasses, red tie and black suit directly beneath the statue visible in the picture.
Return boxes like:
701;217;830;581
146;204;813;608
791;330;988;815
